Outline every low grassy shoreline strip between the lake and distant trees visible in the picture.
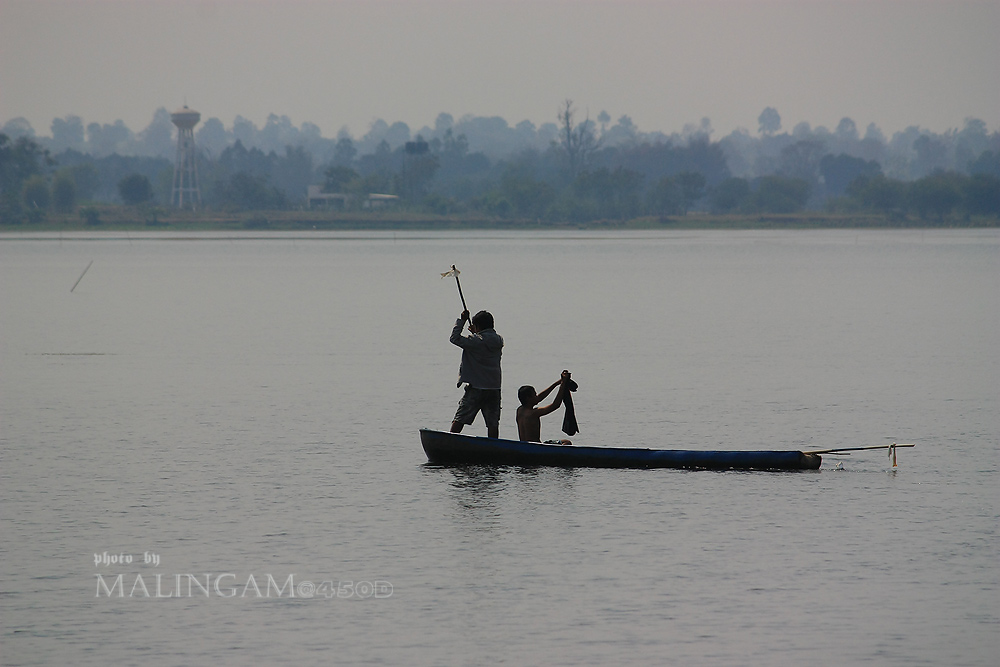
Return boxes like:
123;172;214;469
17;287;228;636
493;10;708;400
0;207;1000;235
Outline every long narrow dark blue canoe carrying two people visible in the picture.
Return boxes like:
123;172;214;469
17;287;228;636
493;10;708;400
420;429;823;470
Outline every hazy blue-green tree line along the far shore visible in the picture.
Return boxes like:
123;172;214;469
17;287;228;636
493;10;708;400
0;100;1000;224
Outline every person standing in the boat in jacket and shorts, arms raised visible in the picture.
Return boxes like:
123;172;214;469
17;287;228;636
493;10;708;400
450;310;503;438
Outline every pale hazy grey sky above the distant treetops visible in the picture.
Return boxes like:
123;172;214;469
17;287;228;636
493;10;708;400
0;0;1000;138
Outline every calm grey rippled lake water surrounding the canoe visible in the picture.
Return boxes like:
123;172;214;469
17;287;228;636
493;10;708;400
0;230;1000;666
